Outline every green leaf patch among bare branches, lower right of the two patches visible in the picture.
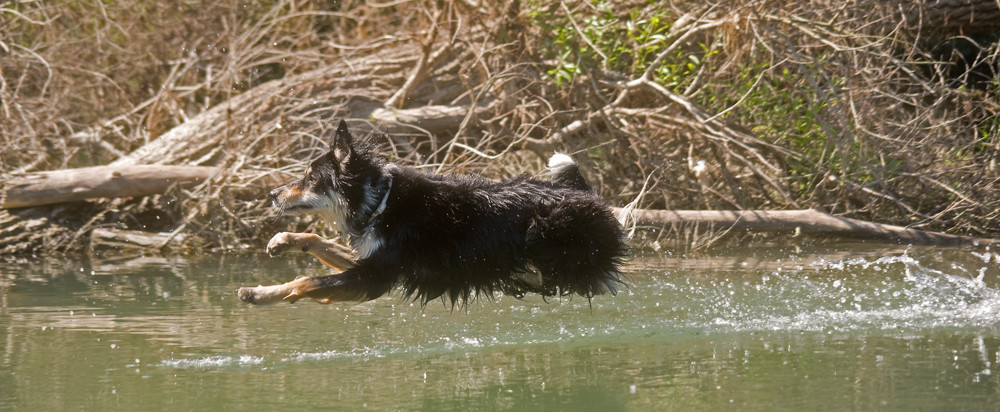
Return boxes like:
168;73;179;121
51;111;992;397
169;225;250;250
698;61;902;198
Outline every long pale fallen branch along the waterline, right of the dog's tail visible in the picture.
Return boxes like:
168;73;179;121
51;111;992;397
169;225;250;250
614;208;1000;246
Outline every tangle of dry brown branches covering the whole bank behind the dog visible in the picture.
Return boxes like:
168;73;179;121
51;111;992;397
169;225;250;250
0;0;1000;254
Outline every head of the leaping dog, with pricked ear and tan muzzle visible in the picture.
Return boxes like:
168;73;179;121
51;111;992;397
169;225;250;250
270;120;384;233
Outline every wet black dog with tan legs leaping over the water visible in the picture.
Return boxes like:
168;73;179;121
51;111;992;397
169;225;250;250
238;121;627;306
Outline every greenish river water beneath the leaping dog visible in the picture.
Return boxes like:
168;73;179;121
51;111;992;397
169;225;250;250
0;244;1000;411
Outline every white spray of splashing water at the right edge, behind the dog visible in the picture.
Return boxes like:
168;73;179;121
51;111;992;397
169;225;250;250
705;249;1000;331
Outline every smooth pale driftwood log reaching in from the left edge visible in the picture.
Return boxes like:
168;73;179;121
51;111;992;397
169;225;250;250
0;165;217;209
